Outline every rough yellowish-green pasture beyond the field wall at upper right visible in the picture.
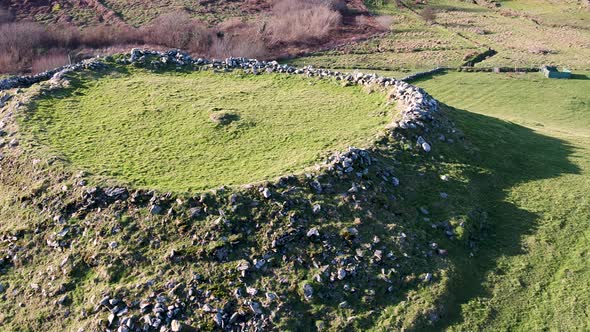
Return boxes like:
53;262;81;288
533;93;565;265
293;0;590;70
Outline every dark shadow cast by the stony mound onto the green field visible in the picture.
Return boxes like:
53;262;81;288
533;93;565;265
424;105;579;330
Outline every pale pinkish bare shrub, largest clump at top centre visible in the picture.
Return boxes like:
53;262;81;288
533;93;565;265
266;0;342;44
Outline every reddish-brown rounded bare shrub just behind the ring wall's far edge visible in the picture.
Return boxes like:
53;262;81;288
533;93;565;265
142;12;212;52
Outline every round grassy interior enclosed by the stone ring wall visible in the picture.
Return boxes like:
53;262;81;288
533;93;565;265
23;71;391;191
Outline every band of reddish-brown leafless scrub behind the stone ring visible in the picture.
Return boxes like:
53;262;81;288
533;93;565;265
0;0;389;73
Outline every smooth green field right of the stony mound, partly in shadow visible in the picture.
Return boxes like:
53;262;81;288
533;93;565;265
419;73;590;330
